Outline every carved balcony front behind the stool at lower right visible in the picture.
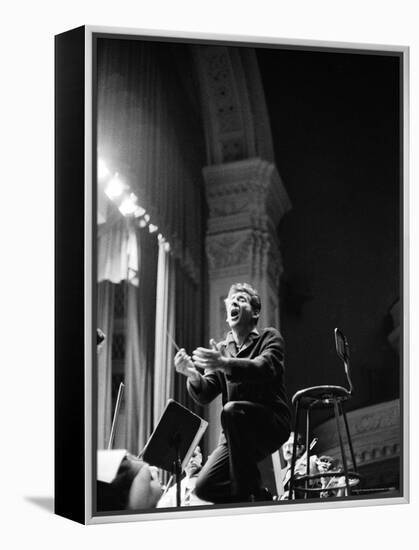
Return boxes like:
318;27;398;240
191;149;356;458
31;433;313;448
314;399;401;466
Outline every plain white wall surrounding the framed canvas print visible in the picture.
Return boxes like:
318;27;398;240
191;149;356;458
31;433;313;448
0;0;419;550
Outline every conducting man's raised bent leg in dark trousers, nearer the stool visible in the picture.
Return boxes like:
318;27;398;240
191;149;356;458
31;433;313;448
221;401;289;501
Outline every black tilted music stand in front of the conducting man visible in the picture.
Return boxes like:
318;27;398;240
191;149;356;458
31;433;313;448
140;399;208;506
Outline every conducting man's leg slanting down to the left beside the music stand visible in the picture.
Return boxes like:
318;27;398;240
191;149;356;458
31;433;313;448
195;442;232;504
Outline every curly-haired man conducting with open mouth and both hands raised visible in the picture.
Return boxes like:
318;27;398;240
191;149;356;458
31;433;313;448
175;283;290;503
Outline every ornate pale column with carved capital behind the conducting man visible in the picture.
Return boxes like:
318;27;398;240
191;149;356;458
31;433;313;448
204;158;291;450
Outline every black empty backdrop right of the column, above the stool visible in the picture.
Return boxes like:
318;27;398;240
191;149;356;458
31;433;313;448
258;49;401;418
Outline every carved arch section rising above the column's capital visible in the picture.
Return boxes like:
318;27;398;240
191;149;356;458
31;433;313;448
192;45;274;164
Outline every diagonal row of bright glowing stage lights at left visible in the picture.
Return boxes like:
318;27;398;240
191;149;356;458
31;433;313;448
97;158;162;238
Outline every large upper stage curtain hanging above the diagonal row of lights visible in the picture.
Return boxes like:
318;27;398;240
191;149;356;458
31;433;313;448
98;39;205;284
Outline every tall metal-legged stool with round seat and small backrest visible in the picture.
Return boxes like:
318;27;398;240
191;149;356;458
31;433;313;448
289;328;360;499
